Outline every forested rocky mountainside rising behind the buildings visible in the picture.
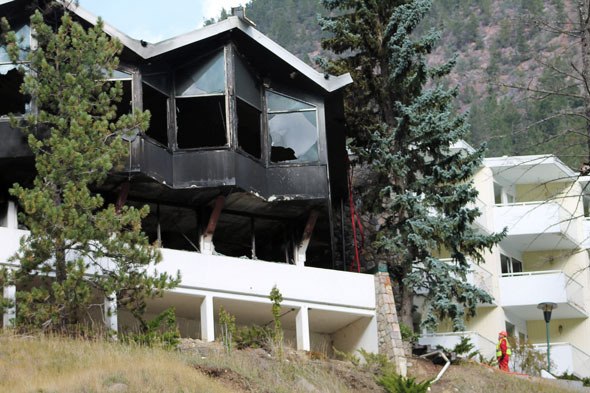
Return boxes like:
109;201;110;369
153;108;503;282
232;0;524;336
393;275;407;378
225;0;588;168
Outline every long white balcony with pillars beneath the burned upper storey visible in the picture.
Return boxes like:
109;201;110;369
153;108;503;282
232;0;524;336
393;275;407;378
0;227;378;352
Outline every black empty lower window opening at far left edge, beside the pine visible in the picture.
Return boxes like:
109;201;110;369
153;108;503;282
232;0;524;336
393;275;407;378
0;65;30;116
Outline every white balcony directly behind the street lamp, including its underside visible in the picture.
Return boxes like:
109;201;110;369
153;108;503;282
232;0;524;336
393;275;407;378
500;270;588;321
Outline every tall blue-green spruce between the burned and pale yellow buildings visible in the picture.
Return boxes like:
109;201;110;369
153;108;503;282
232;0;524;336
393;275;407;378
322;0;502;330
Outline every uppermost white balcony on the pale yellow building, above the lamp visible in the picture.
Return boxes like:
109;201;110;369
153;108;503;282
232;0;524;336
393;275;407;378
494;202;582;251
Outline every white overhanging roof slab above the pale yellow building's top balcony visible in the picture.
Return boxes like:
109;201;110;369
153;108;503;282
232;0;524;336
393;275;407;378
484;155;578;184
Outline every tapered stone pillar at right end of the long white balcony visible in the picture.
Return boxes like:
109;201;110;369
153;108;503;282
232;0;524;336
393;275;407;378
375;271;407;376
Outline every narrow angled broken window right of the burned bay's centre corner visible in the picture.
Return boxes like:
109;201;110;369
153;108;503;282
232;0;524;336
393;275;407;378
235;56;262;158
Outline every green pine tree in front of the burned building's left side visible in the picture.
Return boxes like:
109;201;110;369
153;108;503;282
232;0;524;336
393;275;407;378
3;3;178;331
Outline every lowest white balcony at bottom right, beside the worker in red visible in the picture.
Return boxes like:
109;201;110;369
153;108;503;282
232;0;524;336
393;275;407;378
533;343;590;378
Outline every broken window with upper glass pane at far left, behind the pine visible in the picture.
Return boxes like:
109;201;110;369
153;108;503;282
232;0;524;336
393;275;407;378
0;25;31;116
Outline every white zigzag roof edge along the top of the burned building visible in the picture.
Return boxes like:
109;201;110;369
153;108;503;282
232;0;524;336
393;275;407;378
61;0;352;92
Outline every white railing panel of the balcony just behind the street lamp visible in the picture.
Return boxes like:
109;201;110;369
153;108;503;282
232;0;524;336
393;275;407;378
500;270;586;311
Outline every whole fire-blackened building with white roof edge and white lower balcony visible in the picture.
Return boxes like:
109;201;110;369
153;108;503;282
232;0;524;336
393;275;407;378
0;0;386;352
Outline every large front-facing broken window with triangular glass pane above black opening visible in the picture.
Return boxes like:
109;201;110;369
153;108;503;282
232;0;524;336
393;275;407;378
175;51;227;149
